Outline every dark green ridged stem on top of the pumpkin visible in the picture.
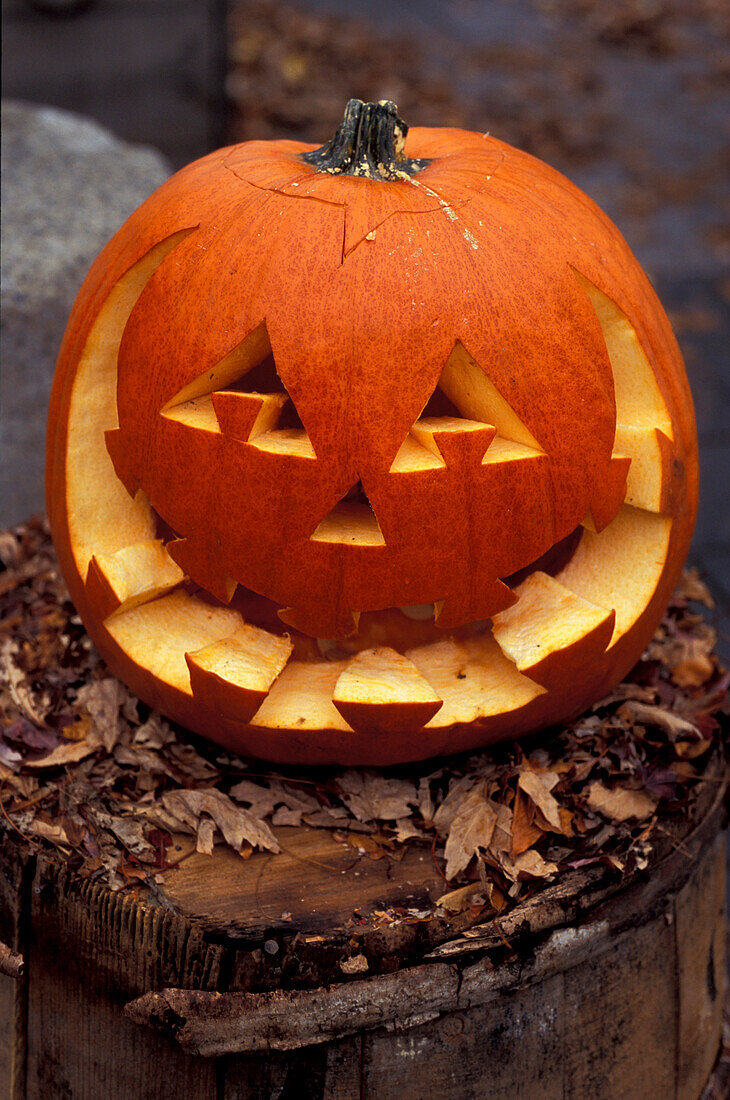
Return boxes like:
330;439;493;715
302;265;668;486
301;99;430;179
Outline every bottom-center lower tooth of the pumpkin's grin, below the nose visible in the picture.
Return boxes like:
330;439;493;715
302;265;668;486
332;646;443;734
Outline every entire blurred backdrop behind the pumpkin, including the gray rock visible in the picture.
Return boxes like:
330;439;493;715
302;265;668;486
0;0;730;657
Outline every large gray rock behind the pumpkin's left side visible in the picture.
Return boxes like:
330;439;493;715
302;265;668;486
0;102;169;526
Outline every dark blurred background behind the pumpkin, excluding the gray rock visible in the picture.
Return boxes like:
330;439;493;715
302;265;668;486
0;0;730;656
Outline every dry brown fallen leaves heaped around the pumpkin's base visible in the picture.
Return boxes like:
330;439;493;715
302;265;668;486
0;519;730;914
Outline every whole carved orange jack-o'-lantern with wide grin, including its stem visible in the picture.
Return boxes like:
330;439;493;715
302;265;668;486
47;101;698;766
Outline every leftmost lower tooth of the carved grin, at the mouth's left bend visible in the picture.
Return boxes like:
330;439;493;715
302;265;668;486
86;539;183;619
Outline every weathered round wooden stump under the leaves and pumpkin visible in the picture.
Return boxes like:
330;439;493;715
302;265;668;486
0;762;725;1100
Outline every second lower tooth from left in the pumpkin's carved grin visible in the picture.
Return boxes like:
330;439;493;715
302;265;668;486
185;623;294;722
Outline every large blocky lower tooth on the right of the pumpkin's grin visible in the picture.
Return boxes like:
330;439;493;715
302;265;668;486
493;572;616;691
